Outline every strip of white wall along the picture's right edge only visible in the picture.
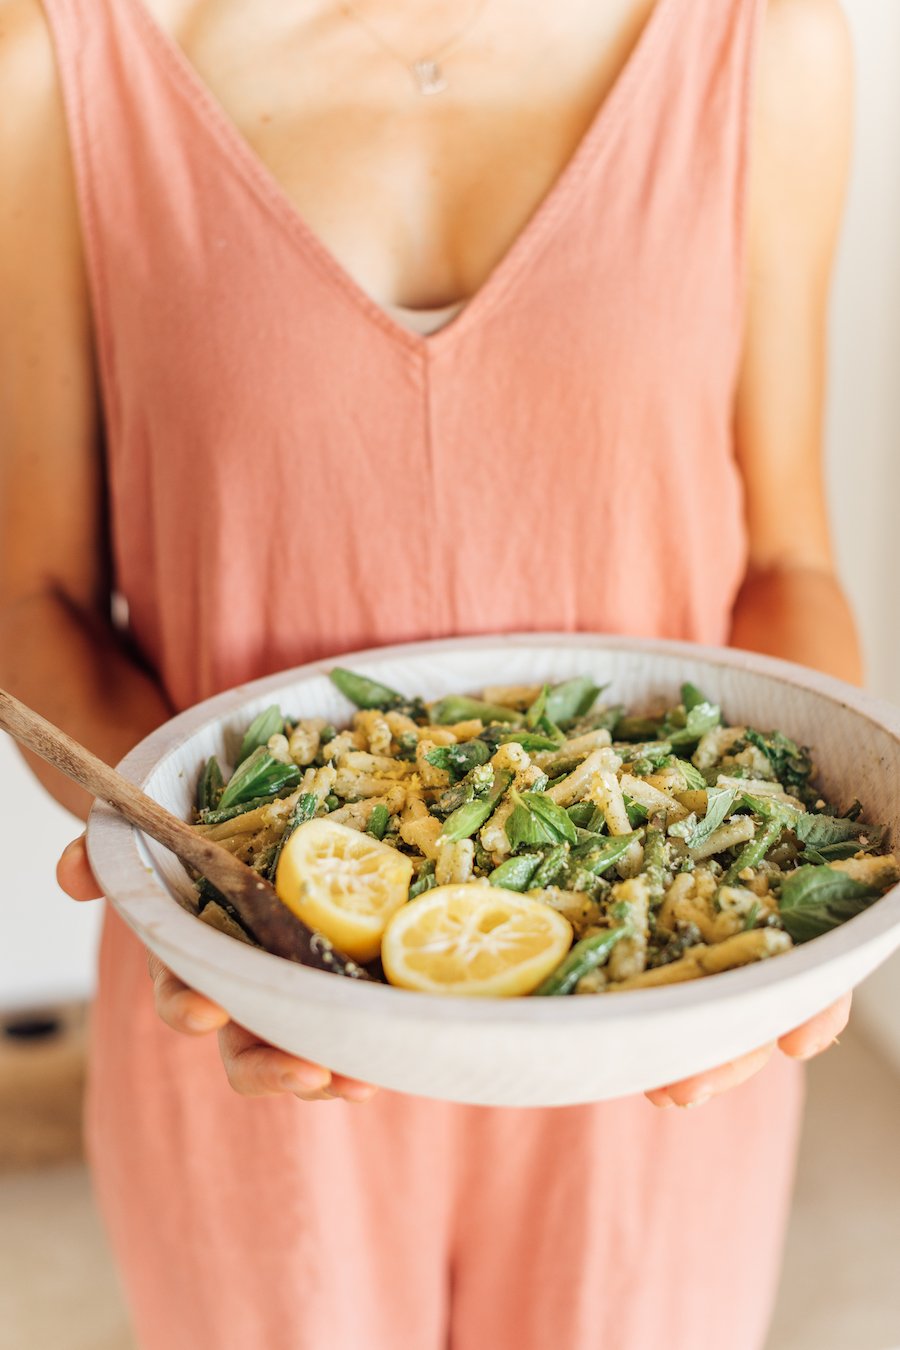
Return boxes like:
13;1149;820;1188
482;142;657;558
827;0;900;1069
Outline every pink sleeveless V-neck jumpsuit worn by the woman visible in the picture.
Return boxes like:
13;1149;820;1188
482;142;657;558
45;0;801;1350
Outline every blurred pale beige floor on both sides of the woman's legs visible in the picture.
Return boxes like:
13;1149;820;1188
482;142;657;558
0;1033;900;1350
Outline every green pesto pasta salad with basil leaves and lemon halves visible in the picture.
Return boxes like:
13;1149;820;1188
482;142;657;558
186;668;900;996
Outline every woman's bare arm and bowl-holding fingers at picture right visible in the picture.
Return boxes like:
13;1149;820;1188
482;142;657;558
648;0;862;1106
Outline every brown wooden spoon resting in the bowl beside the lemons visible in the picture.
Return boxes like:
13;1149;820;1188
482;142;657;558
0;690;372;980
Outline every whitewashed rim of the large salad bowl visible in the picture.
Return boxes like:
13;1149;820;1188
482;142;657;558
88;632;900;1029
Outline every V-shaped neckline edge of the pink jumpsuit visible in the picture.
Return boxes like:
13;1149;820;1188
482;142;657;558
125;0;677;355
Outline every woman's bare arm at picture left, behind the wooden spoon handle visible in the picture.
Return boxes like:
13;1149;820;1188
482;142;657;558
0;0;170;817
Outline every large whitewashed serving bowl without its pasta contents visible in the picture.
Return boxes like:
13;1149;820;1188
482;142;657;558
88;635;900;1106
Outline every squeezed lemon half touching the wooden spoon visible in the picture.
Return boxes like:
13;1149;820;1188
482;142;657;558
275;817;413;961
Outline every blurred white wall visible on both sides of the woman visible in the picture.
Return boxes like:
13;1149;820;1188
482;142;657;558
0;0;900;1031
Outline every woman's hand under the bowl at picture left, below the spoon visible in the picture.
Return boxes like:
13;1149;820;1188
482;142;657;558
57;834;378;1102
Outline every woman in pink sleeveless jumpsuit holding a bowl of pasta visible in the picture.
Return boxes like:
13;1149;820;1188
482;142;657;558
0;0;860;1350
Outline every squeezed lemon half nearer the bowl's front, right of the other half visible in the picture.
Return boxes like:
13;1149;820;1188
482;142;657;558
382;882;572;998
